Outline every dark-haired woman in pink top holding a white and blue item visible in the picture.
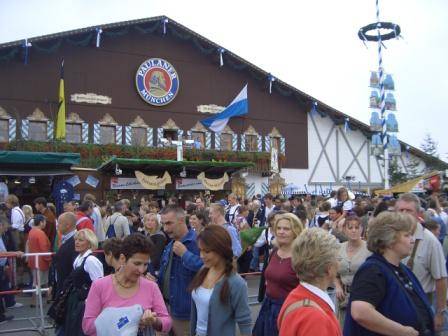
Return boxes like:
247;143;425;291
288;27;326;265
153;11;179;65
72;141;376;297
82;234;171;335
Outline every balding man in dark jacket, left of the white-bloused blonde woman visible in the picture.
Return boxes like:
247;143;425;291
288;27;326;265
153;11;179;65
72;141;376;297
52;212;78;296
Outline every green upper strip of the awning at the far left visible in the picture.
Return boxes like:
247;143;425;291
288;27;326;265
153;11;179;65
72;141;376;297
0;151;81;166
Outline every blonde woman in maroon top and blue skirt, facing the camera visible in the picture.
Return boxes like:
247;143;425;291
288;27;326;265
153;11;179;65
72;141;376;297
252;213;304;336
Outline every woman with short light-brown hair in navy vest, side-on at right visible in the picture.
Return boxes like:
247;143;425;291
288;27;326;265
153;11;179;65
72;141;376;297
344;211;435;336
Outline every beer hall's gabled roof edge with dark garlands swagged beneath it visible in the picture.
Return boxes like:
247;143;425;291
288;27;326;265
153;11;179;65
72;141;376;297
0;16;448;168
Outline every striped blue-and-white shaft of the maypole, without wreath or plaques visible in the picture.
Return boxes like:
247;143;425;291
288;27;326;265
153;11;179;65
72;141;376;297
376;0;389;189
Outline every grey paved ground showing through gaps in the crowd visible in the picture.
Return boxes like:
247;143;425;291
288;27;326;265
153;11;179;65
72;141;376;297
0;277;260;336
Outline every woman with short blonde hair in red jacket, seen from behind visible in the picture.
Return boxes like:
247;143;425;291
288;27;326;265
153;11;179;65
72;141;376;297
277;228;342;336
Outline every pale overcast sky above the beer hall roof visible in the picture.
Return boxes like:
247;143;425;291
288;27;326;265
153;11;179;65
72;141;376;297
0;0;448;159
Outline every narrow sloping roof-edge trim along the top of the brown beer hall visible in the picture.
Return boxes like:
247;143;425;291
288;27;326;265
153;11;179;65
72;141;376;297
0;15;448;168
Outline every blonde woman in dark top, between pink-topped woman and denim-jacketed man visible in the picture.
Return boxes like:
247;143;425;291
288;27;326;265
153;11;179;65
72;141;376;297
143;213;166;275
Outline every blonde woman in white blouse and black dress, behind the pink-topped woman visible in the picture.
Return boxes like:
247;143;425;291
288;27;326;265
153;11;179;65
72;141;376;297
64;229;104;336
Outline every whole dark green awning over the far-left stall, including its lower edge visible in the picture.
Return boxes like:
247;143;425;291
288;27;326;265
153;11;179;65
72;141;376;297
0;151;81;176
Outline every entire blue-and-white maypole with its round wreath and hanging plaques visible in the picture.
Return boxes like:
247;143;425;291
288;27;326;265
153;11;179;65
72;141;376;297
358;0;401;189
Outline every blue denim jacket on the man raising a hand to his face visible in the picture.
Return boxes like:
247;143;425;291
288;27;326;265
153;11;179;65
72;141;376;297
157;230;203;320
